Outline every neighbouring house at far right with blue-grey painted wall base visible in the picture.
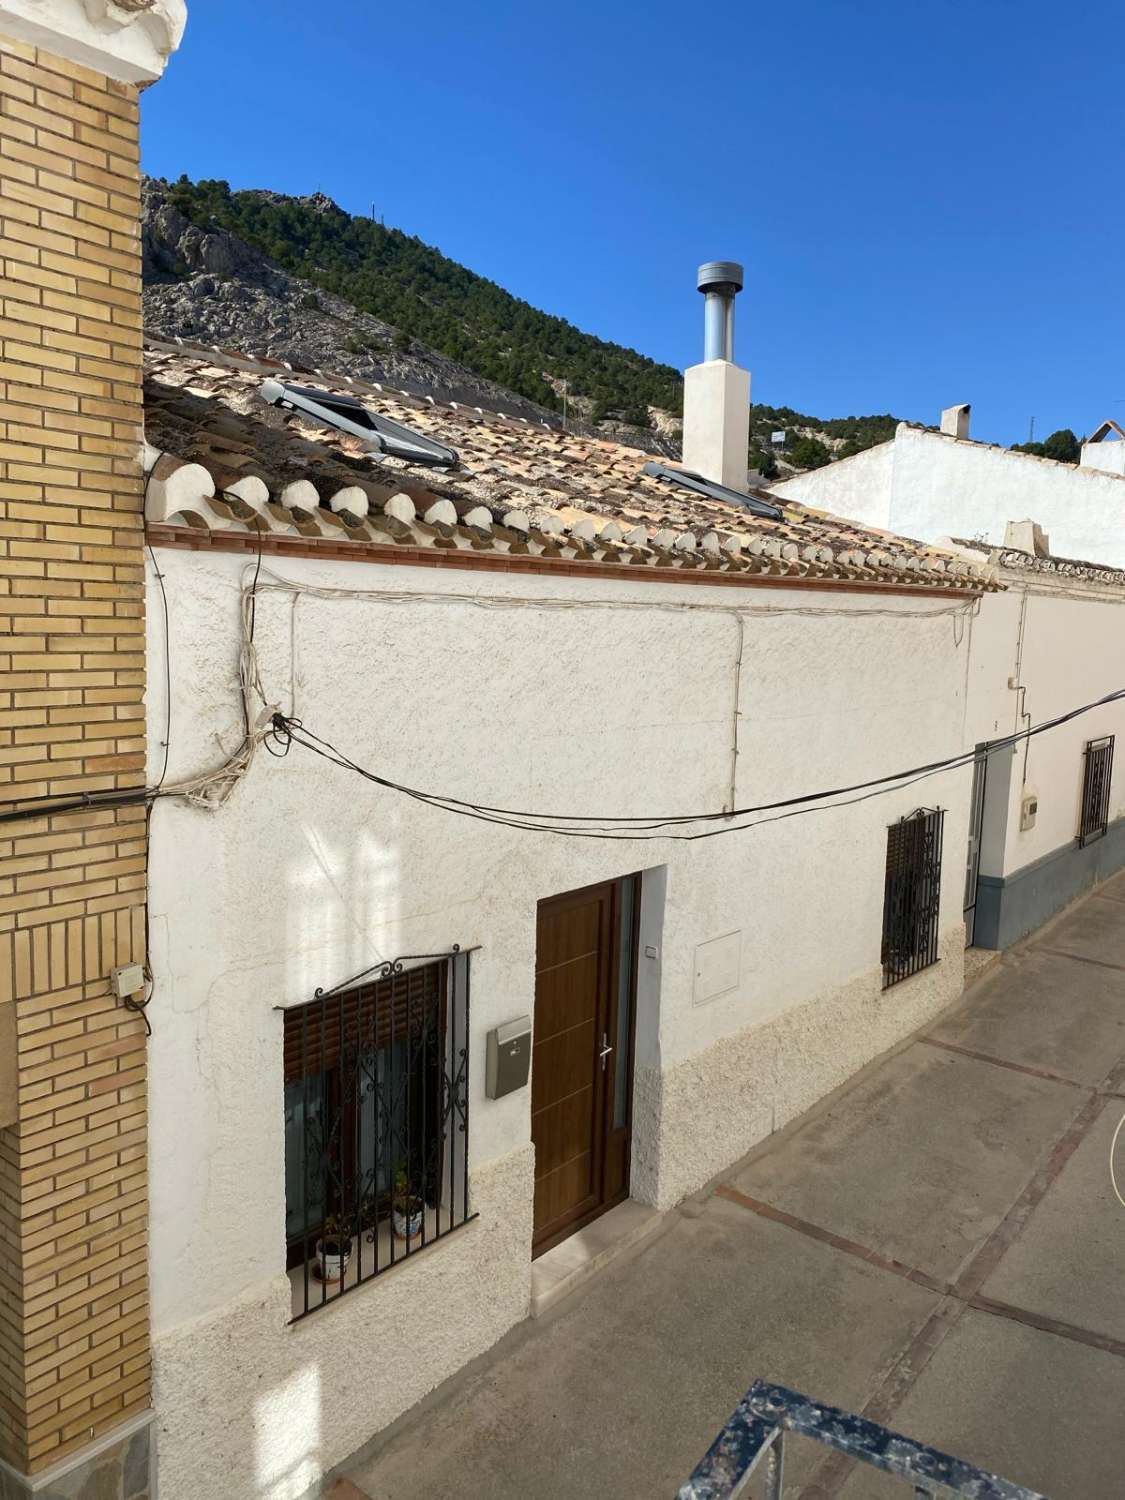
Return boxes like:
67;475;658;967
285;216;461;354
950;534;1125;948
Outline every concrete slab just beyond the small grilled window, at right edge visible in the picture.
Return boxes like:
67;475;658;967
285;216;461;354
929;950;1125;1088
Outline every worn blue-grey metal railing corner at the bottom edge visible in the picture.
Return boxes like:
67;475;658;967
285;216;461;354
677;1380;1046;1500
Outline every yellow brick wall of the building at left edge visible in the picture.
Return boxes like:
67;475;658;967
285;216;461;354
0;39;149;1472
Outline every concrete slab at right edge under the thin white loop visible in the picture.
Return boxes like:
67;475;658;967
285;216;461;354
981;1100;1125;1338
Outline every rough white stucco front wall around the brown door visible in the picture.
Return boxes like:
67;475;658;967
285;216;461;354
149;551;969;1500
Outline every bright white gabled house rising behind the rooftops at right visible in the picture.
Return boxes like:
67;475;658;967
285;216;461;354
773;405;1125;567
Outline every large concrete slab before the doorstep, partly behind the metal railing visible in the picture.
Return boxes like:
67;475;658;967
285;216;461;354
348;1199;938;1500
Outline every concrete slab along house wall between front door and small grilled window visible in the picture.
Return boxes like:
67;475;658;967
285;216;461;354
734;1043;1085;1280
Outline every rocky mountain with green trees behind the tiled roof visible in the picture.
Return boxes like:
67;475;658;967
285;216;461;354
143;177;897;477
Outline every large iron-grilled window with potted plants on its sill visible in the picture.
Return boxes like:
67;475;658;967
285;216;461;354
285;948;473;1317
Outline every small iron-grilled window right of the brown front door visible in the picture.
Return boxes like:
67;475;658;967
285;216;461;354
882;807;945;990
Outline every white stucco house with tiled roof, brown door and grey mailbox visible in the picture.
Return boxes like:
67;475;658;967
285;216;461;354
146;319;999;1500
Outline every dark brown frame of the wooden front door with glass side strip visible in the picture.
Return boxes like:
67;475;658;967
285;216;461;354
531;873;642;1260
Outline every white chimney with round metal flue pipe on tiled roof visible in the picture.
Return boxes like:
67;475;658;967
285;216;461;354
684;261;750;489
